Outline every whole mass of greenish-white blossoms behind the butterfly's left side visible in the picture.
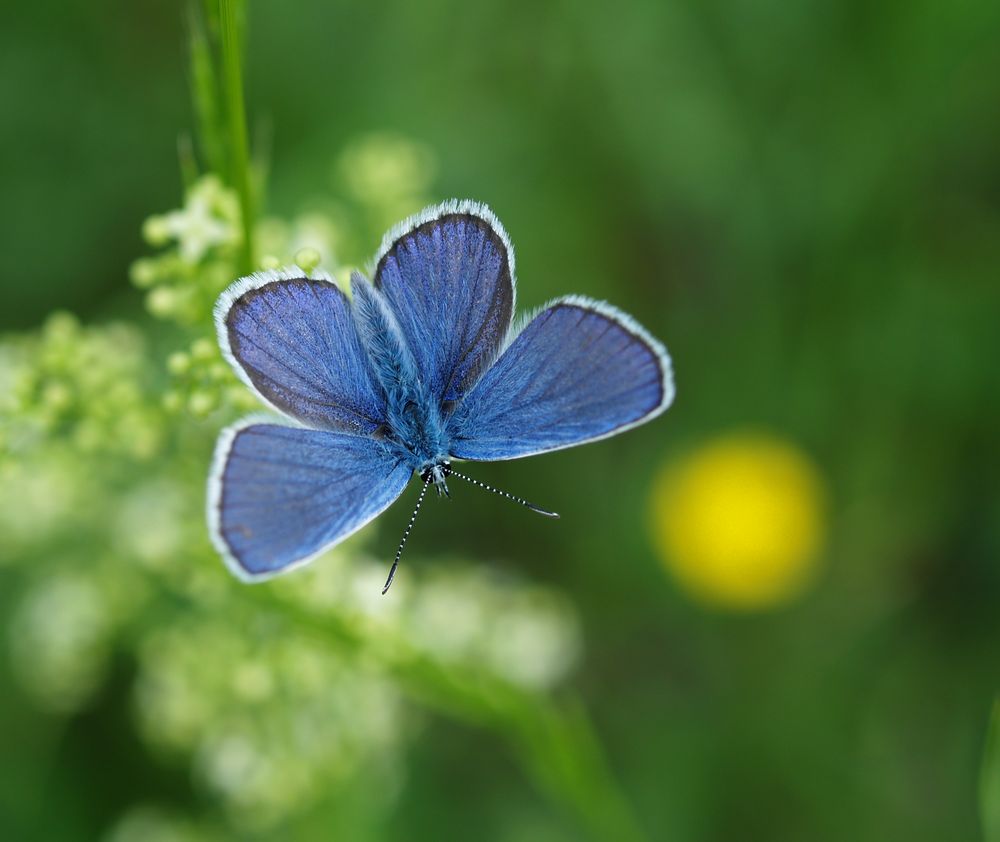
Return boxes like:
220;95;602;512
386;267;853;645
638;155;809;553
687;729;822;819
0;135;596;842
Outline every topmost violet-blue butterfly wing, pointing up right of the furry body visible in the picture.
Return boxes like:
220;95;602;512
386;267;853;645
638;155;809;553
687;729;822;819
374;201;515;403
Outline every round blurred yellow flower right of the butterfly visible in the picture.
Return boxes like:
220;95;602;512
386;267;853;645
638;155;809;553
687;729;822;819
652;433;824;610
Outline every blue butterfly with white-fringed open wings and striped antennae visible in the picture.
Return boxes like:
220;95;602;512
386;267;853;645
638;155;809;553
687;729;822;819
208;201;674;593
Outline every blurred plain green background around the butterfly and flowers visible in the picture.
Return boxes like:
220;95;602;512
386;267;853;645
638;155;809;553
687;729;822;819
0;0;1000;842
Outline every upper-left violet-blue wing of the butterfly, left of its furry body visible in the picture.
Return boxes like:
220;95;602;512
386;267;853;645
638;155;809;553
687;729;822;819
215;270;385;434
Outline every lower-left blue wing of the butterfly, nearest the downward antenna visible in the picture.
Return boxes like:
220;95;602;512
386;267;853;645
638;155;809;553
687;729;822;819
208;419;412;581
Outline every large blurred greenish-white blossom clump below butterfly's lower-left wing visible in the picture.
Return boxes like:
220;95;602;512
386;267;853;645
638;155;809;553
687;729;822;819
136;611;408;828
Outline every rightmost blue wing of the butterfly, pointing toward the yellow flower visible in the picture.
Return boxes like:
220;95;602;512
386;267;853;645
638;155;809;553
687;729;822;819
449;296;674;461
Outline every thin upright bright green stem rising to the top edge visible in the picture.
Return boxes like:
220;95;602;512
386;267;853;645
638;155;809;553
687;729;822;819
219;0;255;274
